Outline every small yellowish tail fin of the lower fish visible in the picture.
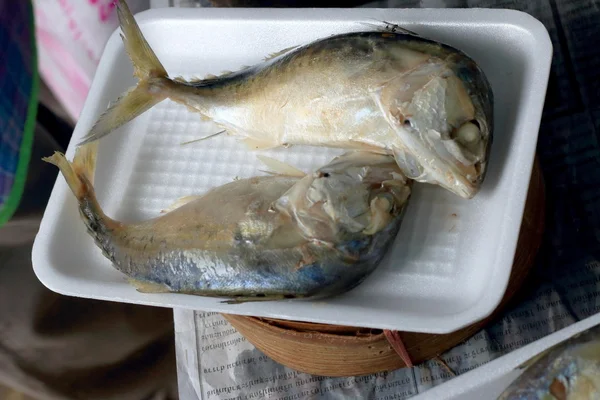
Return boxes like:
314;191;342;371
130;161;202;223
42;143;98;201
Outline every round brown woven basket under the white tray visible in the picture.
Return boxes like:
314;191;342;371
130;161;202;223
224;159;545;376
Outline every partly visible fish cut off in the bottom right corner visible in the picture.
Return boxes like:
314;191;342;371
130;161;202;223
498;326;600;400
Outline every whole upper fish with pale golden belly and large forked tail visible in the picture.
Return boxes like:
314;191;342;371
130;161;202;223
84;3;493;198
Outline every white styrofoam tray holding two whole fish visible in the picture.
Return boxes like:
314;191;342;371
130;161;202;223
33;8;552;333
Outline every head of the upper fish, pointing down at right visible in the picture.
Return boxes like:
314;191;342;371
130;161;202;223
377;59;493;199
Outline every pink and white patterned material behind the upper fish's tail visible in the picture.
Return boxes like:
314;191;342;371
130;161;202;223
33;0;149;121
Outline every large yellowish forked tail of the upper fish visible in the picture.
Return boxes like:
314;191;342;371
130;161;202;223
79;0;170;145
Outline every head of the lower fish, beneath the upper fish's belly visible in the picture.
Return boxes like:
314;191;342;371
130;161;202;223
275;152;411;243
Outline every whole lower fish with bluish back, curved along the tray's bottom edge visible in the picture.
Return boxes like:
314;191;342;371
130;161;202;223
46;148;410;301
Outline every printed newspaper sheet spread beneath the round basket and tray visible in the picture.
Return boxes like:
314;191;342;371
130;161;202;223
175;0;600;400
